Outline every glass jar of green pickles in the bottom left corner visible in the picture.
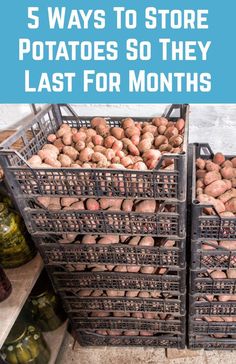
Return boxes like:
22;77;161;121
1;319;50;364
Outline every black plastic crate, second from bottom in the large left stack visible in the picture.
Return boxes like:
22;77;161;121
69;313;185;334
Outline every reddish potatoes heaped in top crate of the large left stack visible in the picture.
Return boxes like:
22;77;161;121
27;117;185;171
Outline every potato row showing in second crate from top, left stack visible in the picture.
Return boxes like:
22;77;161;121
37;196;162;213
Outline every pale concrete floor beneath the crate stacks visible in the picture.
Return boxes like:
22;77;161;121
57;334;236;364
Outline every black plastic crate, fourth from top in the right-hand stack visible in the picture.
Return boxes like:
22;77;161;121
189;295;236;317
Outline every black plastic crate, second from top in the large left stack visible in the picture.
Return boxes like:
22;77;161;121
20;199;186;239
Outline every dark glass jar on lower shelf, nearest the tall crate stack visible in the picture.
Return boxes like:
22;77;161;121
27;270;66;332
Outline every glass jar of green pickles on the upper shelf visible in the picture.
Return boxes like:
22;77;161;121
0;202;36;268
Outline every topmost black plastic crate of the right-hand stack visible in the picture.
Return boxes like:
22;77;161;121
191;144;236;240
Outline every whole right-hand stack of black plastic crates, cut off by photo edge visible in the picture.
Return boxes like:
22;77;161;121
189;144;236;350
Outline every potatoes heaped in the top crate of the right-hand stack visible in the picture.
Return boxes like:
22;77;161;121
196;153;236;217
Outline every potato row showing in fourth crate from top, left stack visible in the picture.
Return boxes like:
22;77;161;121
65;263;168;275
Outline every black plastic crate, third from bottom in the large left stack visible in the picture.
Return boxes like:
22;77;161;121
59;291;185;316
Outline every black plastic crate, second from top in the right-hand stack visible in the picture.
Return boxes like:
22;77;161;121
191;241;236;270
